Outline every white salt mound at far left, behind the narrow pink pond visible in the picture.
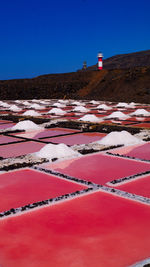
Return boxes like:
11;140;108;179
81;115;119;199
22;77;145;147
11;120;43;131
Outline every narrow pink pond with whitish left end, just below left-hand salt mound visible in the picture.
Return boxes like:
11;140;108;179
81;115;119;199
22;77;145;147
10;128;79;139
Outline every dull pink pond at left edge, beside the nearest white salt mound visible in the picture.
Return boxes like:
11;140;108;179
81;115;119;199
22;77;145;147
0;141;45;158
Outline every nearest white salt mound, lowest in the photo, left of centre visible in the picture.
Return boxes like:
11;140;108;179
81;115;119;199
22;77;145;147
35;144;81;160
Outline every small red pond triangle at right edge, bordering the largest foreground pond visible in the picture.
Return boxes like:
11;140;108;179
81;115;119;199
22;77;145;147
115;175;150;198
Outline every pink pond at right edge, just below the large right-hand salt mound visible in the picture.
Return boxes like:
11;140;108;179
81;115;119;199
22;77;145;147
111;142;150;160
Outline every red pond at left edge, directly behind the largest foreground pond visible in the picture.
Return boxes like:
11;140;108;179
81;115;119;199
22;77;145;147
0;169;86;212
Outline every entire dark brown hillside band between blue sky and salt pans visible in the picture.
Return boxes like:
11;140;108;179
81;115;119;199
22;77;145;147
0;50;150;103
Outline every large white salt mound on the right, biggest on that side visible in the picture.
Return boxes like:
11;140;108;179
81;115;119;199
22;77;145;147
94;131;144;146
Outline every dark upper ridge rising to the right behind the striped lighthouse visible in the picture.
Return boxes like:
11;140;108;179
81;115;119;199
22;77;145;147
87;50;150;70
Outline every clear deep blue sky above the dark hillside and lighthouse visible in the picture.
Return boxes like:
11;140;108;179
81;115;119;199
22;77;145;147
0;0;150;79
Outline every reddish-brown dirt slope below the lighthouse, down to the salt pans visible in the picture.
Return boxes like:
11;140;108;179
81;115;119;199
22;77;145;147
78;67;150;103
